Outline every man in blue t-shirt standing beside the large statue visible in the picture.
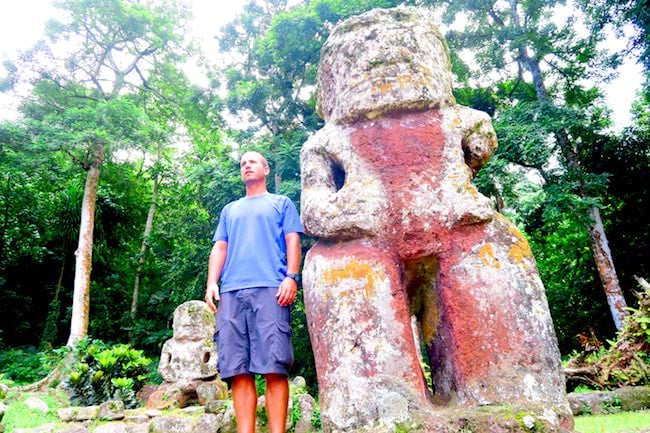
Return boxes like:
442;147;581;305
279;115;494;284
205;152;303;433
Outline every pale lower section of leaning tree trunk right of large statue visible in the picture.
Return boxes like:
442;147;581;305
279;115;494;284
589;207;628;329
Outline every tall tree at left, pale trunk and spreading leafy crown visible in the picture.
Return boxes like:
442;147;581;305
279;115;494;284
5;0;188;345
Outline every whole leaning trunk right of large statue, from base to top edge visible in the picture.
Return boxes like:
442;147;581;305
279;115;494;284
509;0;627;329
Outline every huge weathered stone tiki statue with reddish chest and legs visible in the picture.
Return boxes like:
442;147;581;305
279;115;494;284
301;8;572;432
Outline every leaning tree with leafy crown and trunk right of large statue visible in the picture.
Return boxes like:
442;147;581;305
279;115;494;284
422;0;626;328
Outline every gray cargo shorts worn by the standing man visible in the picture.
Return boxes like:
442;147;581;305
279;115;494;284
215;287;293;379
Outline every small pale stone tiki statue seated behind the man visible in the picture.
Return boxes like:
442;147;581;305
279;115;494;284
147;301;227;409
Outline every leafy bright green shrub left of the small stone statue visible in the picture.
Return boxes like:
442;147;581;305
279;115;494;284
65;340;151;408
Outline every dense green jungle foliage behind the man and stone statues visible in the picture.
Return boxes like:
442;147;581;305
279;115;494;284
0;0;650;398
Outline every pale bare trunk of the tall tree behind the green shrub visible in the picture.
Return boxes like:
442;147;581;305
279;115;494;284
67;143;105;347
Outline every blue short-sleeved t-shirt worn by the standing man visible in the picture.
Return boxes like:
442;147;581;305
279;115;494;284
212;193;303;293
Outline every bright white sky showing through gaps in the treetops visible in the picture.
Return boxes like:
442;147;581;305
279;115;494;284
0;0;642;129
